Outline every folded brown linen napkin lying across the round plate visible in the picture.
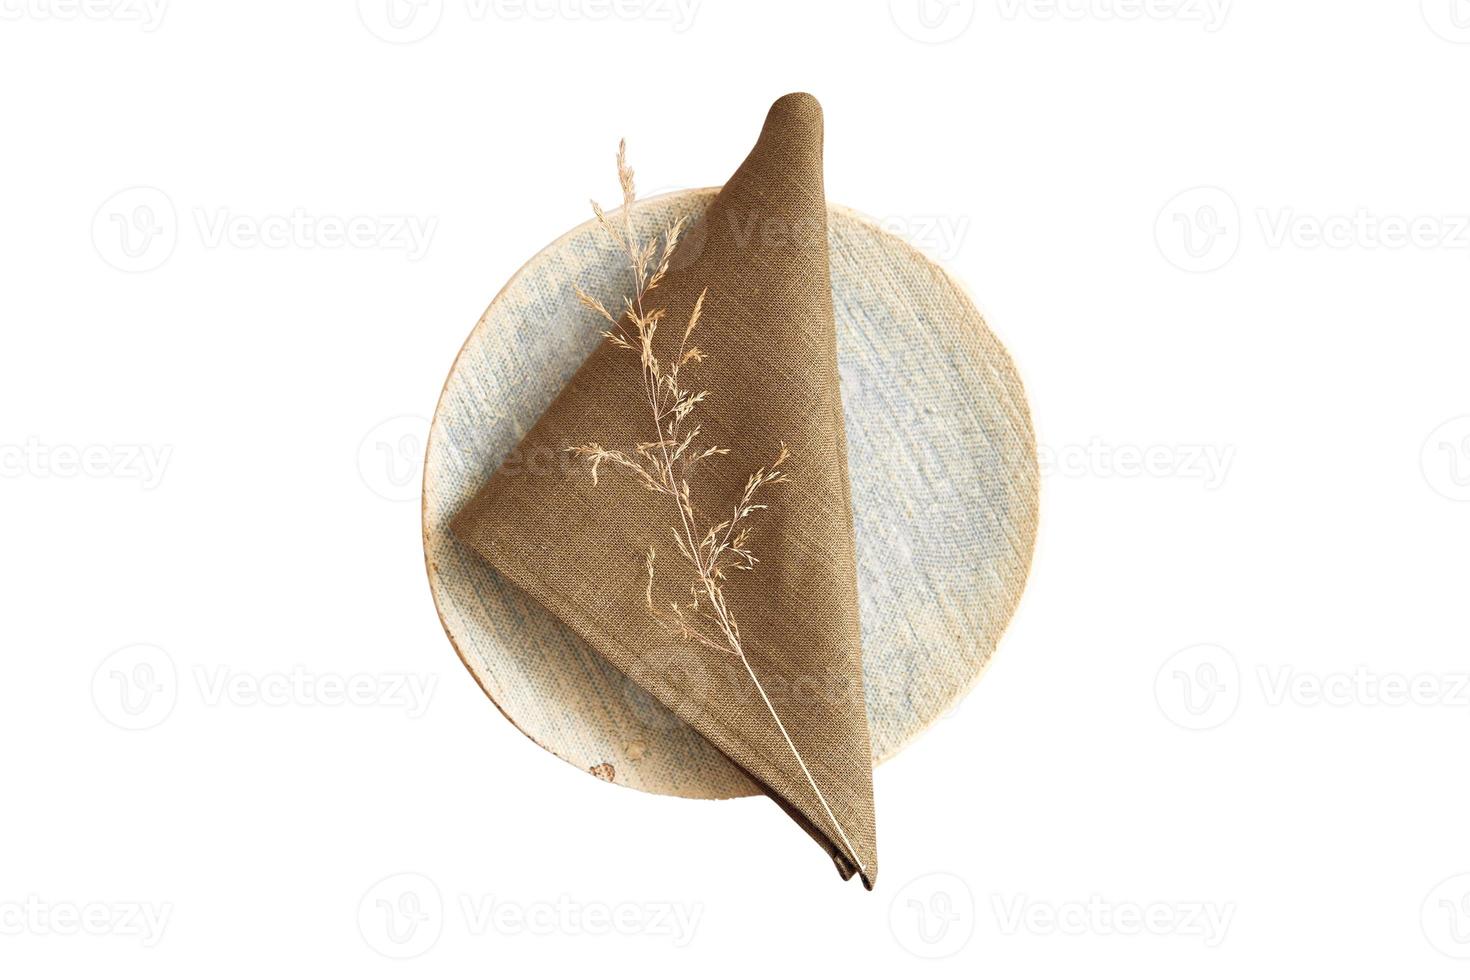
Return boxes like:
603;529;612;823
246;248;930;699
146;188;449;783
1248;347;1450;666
453;93;878;889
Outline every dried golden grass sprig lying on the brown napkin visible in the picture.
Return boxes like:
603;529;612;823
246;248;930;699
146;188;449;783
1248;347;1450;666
567;141;867;874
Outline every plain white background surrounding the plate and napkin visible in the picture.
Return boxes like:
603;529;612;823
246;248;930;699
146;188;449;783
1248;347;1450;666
0;0;1470;977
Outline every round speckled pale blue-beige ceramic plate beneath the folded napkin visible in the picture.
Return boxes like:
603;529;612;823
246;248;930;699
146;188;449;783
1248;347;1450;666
423;188;1036;799
